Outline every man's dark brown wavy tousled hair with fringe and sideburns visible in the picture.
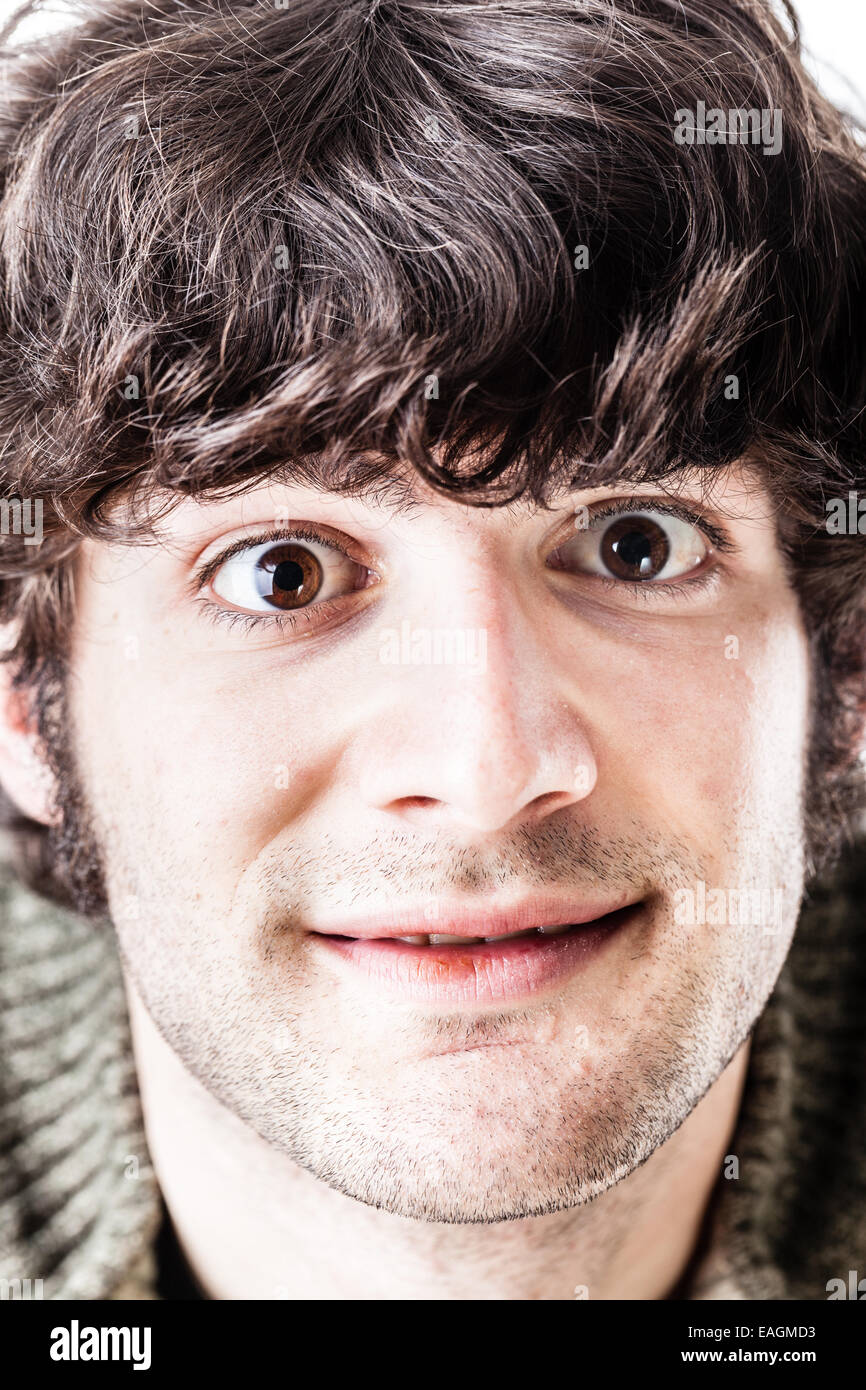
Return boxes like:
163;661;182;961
0;0;866;910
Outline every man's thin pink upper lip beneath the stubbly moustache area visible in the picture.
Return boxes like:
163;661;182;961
307;895;639;941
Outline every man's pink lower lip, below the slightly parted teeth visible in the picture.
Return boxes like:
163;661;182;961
313;902;642;1004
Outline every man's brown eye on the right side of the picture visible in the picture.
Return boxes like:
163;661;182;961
550;507;710;584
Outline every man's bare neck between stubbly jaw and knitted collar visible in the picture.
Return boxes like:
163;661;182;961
126;981;749;1301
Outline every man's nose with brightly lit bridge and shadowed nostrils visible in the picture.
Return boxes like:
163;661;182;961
361;599;598;835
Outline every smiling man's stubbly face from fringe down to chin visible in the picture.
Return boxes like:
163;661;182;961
62;470;809;1220
